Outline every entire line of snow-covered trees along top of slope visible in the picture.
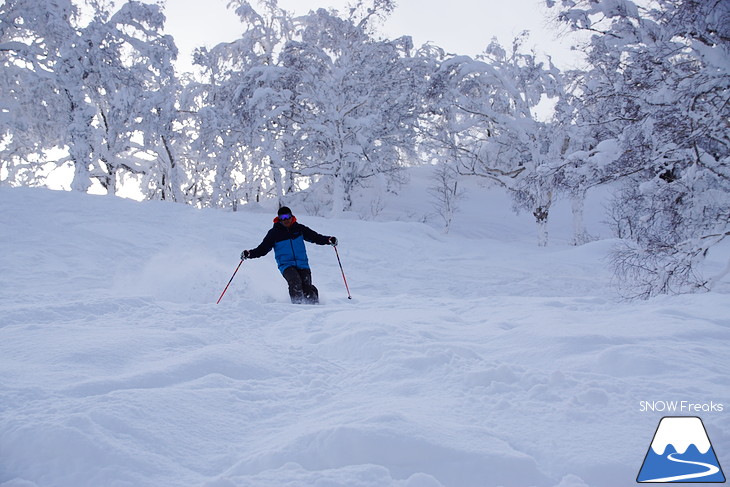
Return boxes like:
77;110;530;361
0;0;730;297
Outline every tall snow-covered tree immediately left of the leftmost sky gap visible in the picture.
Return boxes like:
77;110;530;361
78;1;179;196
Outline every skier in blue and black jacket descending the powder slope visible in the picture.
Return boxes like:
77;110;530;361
241;206;337;304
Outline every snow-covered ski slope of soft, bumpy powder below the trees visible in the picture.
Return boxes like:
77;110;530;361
0;184;730;487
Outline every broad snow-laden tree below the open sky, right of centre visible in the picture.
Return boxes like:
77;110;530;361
429;37;566;245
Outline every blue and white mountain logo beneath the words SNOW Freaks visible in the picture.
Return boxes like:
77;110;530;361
636;416;725;483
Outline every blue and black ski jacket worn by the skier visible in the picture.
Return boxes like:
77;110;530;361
249;217;330;274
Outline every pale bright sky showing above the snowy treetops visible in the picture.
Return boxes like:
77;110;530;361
159;0;575;68
